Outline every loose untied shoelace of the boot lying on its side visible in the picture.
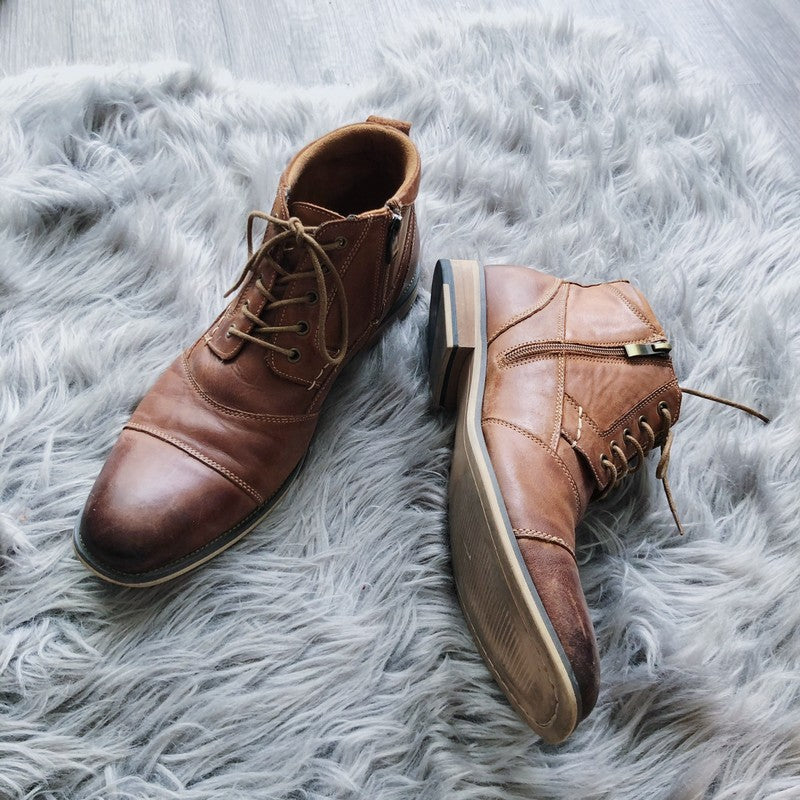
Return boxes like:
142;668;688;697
600;386;769;536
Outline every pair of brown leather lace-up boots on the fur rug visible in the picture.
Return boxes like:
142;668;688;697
74;117;768;742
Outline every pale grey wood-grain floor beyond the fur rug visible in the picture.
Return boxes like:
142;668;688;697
0;0;800;166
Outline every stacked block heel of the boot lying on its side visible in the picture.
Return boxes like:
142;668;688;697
428;259;482;411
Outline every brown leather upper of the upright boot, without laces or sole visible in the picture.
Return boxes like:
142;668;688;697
79;120;419;575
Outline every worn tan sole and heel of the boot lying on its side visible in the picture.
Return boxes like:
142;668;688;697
428;260;581;743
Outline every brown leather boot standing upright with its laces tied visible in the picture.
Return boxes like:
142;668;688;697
74;117;420;586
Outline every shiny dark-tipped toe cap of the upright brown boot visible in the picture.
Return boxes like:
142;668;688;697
76;429;257;584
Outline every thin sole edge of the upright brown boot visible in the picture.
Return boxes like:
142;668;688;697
72;278;417;589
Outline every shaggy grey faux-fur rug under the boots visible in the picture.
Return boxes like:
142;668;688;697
0;12;800;800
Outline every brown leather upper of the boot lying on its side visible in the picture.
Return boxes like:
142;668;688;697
482;266;681;716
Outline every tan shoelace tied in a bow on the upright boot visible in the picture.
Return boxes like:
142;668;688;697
225;211;348;366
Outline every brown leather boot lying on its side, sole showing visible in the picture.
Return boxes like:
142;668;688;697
428;261;766;742
